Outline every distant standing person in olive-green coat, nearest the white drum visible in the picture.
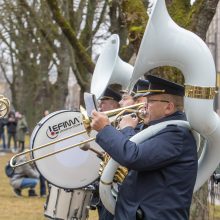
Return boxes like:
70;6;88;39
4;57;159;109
15;112;28;152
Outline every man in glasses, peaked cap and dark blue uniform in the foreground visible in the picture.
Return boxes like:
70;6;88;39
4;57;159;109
91;75;198;220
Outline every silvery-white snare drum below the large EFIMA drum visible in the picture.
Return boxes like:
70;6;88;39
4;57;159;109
44;184;93;220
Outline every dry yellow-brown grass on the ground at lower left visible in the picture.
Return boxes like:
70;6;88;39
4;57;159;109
0;149;98;220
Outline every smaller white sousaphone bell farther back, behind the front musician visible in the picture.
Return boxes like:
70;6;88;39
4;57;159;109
90;34;133;99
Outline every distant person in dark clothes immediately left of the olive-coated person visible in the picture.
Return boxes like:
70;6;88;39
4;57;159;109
7;111;17;152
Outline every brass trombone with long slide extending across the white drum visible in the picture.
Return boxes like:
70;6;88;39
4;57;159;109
10;103;144;168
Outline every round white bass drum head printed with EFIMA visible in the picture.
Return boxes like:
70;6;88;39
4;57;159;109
31;110;103;189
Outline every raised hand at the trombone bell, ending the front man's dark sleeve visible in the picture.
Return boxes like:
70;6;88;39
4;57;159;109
91;110;111;131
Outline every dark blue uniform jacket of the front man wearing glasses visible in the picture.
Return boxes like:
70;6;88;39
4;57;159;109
96;112;198;220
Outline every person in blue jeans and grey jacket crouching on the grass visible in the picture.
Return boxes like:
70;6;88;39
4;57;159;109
10;156;39;197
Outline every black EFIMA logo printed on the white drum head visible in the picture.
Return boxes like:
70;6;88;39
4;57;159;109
46;118;81;139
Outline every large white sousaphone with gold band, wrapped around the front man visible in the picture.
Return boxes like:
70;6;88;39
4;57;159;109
99;0;220;214
